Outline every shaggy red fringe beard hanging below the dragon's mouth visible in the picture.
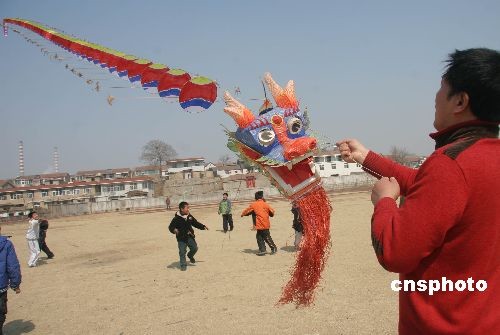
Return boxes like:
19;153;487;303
278;187;330;306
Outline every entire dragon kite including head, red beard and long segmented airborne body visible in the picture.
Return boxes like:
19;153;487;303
3;19;331;305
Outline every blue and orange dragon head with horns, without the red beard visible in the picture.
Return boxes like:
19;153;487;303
224;73;320;198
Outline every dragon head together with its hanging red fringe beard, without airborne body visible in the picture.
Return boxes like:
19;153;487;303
224;73;331;305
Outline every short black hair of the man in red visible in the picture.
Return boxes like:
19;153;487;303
443;48;500;122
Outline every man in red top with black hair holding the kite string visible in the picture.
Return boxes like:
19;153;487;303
337;49;500;335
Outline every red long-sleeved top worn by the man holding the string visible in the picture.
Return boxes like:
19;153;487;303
363;122;500;335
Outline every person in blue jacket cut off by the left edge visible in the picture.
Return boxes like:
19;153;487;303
0;227;21;335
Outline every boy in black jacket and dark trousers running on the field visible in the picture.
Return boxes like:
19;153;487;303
168;201;208;271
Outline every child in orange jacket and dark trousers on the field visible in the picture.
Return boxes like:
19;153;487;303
241;191;278;256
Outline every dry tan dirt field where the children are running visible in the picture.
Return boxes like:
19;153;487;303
2;192;398;335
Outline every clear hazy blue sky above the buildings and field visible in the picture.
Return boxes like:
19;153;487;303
0;0;500;178
